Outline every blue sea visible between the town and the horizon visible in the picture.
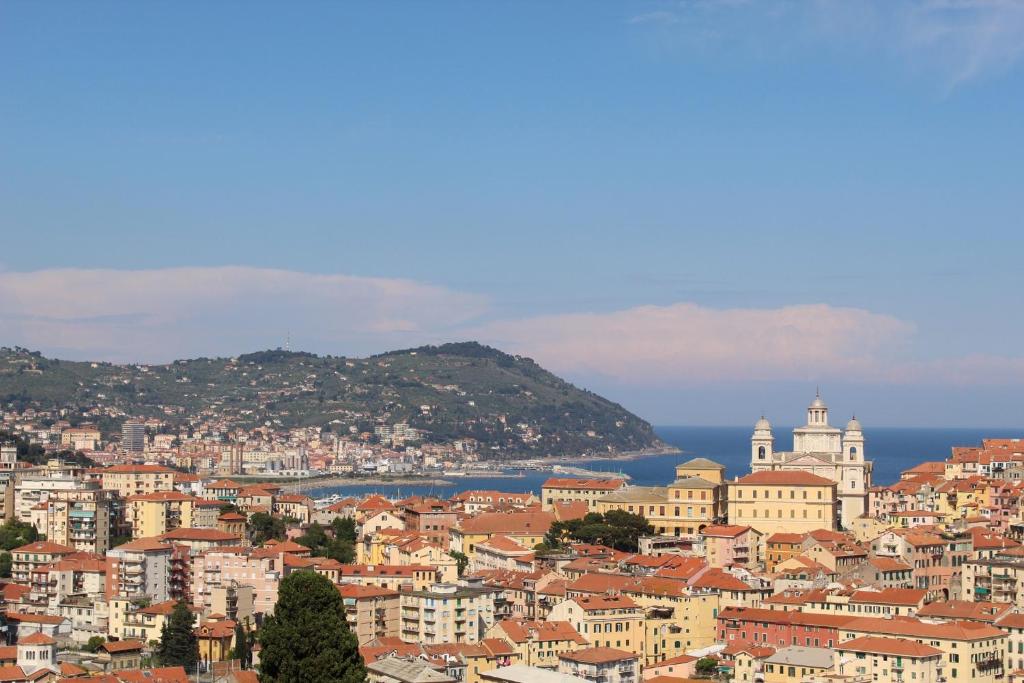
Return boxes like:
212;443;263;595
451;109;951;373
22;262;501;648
306;426;1024;499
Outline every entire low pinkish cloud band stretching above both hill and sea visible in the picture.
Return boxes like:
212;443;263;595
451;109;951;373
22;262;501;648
6;266;1024;387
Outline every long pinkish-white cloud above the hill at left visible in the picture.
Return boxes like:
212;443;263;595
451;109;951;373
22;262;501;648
0;266;486;361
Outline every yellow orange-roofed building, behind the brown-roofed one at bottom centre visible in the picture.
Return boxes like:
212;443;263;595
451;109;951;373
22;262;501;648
548;595;645;656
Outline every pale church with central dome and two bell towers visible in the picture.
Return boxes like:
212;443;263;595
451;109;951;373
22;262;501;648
751;393;871;528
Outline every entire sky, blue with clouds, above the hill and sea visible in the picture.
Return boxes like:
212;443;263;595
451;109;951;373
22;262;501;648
0;0;1024;426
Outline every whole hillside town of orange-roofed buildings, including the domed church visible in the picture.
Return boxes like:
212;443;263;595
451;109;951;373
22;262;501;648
0;396;1024;683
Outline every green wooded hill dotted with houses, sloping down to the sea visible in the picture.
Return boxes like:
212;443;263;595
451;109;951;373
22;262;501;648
0;342;664;456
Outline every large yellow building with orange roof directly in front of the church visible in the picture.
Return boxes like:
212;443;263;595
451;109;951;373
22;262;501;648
728;470;839;535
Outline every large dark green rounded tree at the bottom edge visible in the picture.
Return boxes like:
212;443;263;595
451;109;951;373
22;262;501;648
259;571;367;683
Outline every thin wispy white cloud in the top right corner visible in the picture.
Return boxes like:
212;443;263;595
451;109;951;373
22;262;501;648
629;0;1024;89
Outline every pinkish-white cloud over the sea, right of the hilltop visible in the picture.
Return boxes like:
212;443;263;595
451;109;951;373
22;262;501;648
476;303;912;384
